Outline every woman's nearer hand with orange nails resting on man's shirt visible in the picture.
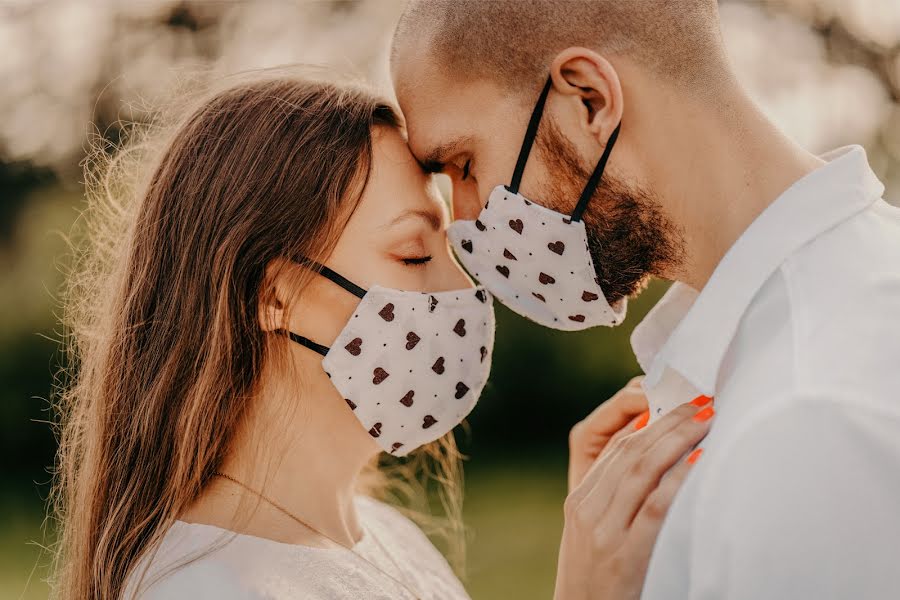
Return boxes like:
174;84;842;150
554;397;714;600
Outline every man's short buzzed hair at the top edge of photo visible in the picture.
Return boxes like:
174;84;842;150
391;0;725;89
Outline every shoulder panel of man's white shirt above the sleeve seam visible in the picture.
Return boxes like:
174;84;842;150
780;201;900;406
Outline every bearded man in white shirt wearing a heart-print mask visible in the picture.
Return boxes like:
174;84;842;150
391;0;900;600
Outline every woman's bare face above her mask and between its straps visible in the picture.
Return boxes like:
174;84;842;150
289;127;473;352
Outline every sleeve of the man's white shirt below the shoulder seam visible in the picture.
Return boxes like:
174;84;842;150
692;394;900;598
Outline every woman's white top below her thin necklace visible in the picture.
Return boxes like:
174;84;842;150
125;496;469;600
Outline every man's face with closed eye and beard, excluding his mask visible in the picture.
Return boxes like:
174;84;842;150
394;61;681;303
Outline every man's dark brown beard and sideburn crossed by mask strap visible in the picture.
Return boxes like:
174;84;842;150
537;119;683;304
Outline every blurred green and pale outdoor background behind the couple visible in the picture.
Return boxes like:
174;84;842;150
0;0;900;599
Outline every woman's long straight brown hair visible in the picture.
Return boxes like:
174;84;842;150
54;75;459;600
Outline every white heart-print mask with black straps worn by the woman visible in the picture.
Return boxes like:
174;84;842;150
279;263;494;456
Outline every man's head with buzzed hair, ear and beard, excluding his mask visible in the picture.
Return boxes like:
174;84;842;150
391;0;736;303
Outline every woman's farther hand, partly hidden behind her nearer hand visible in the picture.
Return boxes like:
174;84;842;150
569;376;650;493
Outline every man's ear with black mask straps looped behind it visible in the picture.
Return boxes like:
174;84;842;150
550;47;624;145
